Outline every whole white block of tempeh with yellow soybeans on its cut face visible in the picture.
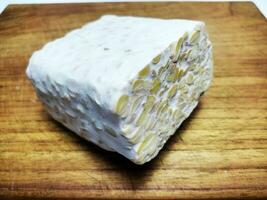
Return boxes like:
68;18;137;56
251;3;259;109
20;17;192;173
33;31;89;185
27;15;213;164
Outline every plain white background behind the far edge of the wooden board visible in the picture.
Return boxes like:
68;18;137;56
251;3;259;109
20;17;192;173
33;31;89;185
0;0;267;18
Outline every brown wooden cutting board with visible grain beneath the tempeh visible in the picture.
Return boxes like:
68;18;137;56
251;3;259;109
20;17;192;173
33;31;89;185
0;3;267;199
